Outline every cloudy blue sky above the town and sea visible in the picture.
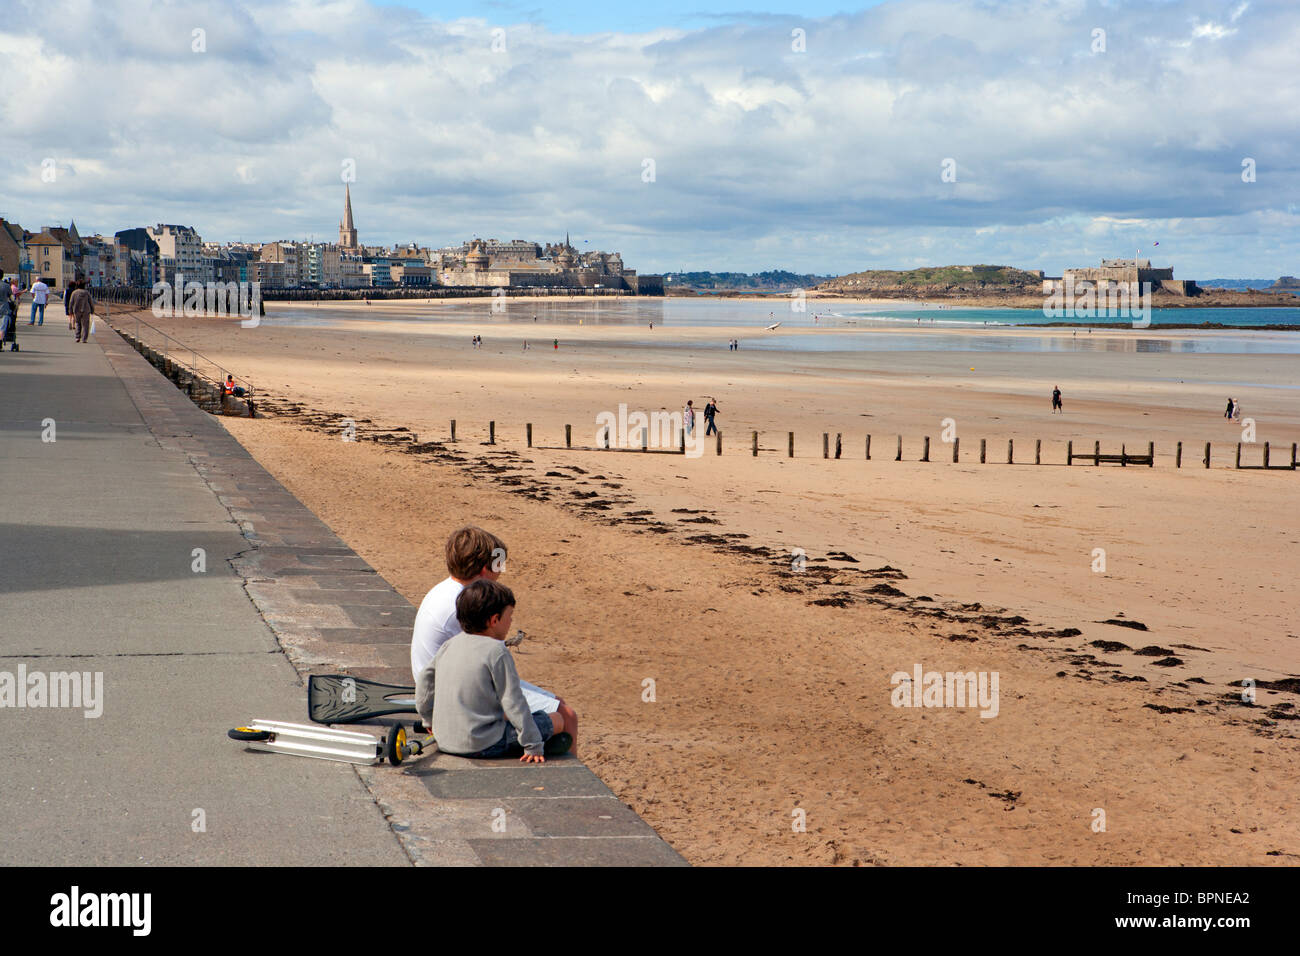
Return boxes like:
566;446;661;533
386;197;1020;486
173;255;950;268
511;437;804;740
0;0;1300;278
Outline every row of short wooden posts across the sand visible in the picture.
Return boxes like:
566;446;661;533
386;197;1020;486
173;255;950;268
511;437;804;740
411;419;1300;471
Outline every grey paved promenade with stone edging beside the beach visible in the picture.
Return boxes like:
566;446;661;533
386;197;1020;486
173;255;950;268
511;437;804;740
0;315;683;865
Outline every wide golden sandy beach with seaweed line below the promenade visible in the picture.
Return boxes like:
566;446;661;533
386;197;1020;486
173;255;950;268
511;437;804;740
122;300;1300;865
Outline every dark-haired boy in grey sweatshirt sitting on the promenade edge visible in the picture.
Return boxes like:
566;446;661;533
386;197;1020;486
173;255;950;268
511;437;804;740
415;579;577;763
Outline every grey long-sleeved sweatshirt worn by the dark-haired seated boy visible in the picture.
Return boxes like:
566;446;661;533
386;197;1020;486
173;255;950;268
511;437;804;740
415;631;542;753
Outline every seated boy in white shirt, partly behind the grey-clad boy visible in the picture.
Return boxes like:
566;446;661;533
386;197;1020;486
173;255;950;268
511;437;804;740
411;525;577;736
